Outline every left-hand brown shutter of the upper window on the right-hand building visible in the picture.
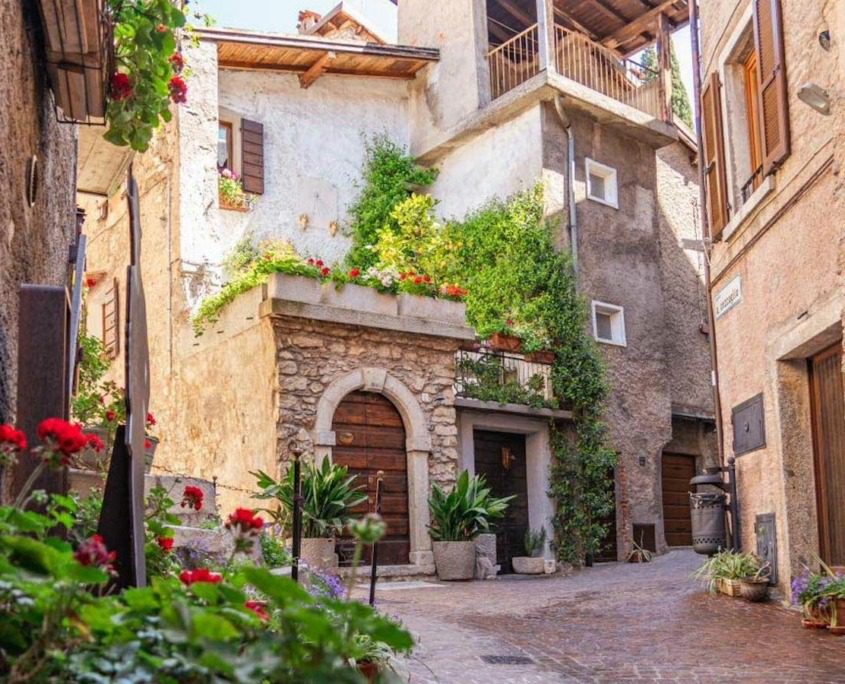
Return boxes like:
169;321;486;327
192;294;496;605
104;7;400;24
701;72;728;240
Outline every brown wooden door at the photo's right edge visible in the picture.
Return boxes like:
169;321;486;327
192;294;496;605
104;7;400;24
809;342;845;566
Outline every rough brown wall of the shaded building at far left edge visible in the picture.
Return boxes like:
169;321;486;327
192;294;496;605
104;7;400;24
0;2;76;423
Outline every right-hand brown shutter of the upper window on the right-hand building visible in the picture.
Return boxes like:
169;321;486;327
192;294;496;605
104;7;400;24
754;0;789;175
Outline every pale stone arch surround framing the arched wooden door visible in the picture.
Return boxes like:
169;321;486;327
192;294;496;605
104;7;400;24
312;367;434;574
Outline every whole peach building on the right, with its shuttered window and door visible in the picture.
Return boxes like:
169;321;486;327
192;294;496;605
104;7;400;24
700;0;845;592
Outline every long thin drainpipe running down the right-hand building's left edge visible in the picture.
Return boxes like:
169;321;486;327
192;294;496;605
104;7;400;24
690;0;741;551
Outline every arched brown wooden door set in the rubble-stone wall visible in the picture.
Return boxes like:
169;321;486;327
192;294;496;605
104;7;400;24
332;392;411;565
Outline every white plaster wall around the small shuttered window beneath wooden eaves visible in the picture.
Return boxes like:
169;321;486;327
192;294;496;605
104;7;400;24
180;43;409;303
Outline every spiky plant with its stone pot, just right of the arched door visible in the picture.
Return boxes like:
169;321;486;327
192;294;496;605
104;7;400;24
428;470;514;580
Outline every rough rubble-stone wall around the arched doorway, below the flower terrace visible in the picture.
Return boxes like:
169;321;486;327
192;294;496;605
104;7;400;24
273;317;459;486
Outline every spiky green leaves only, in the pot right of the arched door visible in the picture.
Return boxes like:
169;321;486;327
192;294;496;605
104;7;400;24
428;470;514;541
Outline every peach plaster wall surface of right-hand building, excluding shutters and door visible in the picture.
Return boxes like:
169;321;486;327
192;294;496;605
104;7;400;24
700;0;845;593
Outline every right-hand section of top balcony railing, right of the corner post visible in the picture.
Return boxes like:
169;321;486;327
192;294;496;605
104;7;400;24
555;26;661;118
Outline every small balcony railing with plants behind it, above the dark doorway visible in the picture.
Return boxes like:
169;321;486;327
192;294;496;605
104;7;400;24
455;350;555;407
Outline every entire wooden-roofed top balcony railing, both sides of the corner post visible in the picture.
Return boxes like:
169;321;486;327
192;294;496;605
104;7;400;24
487;24;661;118
